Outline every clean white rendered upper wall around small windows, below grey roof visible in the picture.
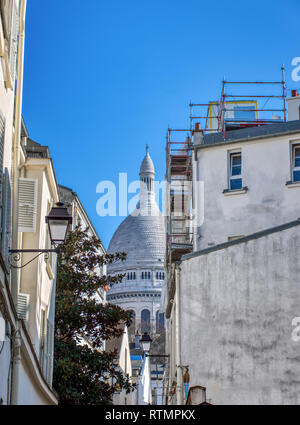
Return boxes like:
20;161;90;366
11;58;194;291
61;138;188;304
193;134;300;250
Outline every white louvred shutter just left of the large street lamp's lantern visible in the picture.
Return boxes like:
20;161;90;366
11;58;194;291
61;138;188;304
18;178;37;233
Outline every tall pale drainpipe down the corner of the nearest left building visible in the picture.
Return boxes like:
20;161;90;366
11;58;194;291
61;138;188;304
11;0;27;305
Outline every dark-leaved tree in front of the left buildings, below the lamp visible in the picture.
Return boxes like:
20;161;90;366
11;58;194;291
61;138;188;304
53;228;132;405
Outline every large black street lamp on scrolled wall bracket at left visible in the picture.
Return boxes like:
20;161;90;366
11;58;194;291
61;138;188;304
9;202;72;269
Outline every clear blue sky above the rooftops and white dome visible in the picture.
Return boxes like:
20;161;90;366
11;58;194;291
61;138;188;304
23;0;300;247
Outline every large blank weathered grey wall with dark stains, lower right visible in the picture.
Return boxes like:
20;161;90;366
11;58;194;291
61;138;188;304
180;226;300;404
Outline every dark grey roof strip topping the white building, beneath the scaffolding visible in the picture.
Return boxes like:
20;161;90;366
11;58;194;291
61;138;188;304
196;120;300;149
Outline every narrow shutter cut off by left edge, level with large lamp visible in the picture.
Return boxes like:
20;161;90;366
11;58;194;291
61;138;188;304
1;168;11;267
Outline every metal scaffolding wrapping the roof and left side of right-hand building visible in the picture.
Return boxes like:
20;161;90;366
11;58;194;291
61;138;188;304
165;65;287;317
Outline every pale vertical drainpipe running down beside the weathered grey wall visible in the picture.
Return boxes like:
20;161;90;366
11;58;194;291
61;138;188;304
175;264;183;405
